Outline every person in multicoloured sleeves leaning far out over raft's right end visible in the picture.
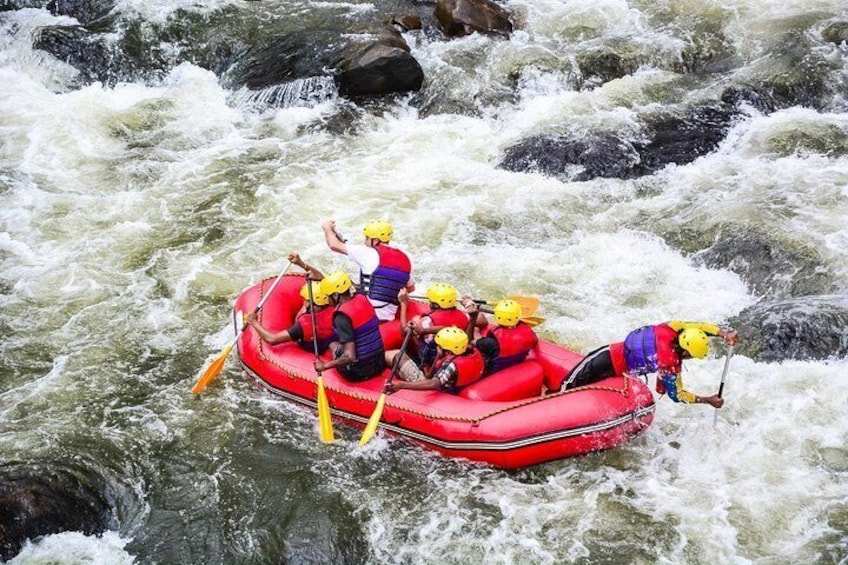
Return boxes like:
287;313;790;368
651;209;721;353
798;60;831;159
560;321;738;408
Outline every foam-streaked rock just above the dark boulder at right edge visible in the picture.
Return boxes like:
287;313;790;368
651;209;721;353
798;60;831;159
695;226;833;299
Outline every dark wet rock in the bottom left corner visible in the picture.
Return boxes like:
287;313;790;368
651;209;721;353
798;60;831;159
0;464;115;560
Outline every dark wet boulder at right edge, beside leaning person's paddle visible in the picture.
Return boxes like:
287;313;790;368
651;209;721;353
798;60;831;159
731;295;848;361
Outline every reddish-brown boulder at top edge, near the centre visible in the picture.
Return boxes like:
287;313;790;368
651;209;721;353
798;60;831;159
434;0;512;37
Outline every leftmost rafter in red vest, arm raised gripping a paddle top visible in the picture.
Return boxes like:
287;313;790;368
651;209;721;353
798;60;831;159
244;253;336;353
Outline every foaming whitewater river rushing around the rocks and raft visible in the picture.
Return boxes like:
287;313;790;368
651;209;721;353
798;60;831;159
0;0;848;565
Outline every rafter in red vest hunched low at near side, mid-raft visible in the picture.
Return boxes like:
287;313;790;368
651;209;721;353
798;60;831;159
385;326;485;393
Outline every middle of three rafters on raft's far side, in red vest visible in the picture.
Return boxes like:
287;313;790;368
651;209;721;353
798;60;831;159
398;283;471;366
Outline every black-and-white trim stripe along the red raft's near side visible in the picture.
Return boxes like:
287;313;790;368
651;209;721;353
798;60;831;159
238;355;656;451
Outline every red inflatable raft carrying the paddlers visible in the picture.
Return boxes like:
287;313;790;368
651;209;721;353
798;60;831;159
235;274;654;468
